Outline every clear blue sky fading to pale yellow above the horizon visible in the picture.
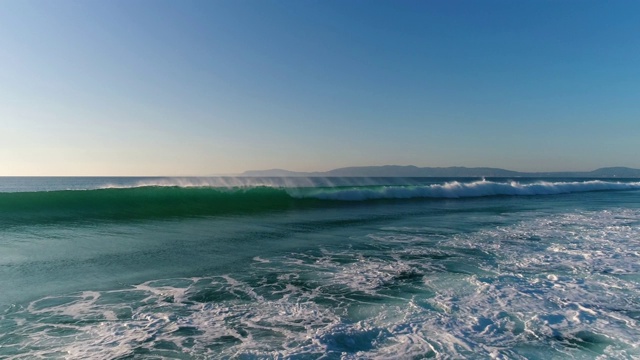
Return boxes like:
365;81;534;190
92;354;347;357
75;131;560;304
0;0;640;176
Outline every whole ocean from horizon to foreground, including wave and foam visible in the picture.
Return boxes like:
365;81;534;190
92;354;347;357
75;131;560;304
0;177;640;359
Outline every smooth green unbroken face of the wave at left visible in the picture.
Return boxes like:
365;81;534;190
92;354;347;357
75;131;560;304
0;187;302;225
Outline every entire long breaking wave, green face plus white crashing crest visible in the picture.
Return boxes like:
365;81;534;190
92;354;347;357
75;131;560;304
0;180;640;223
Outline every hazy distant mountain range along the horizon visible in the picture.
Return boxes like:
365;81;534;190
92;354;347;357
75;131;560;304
241;165;640;178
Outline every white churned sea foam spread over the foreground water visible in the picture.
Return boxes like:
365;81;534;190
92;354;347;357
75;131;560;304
0;209;640;359
